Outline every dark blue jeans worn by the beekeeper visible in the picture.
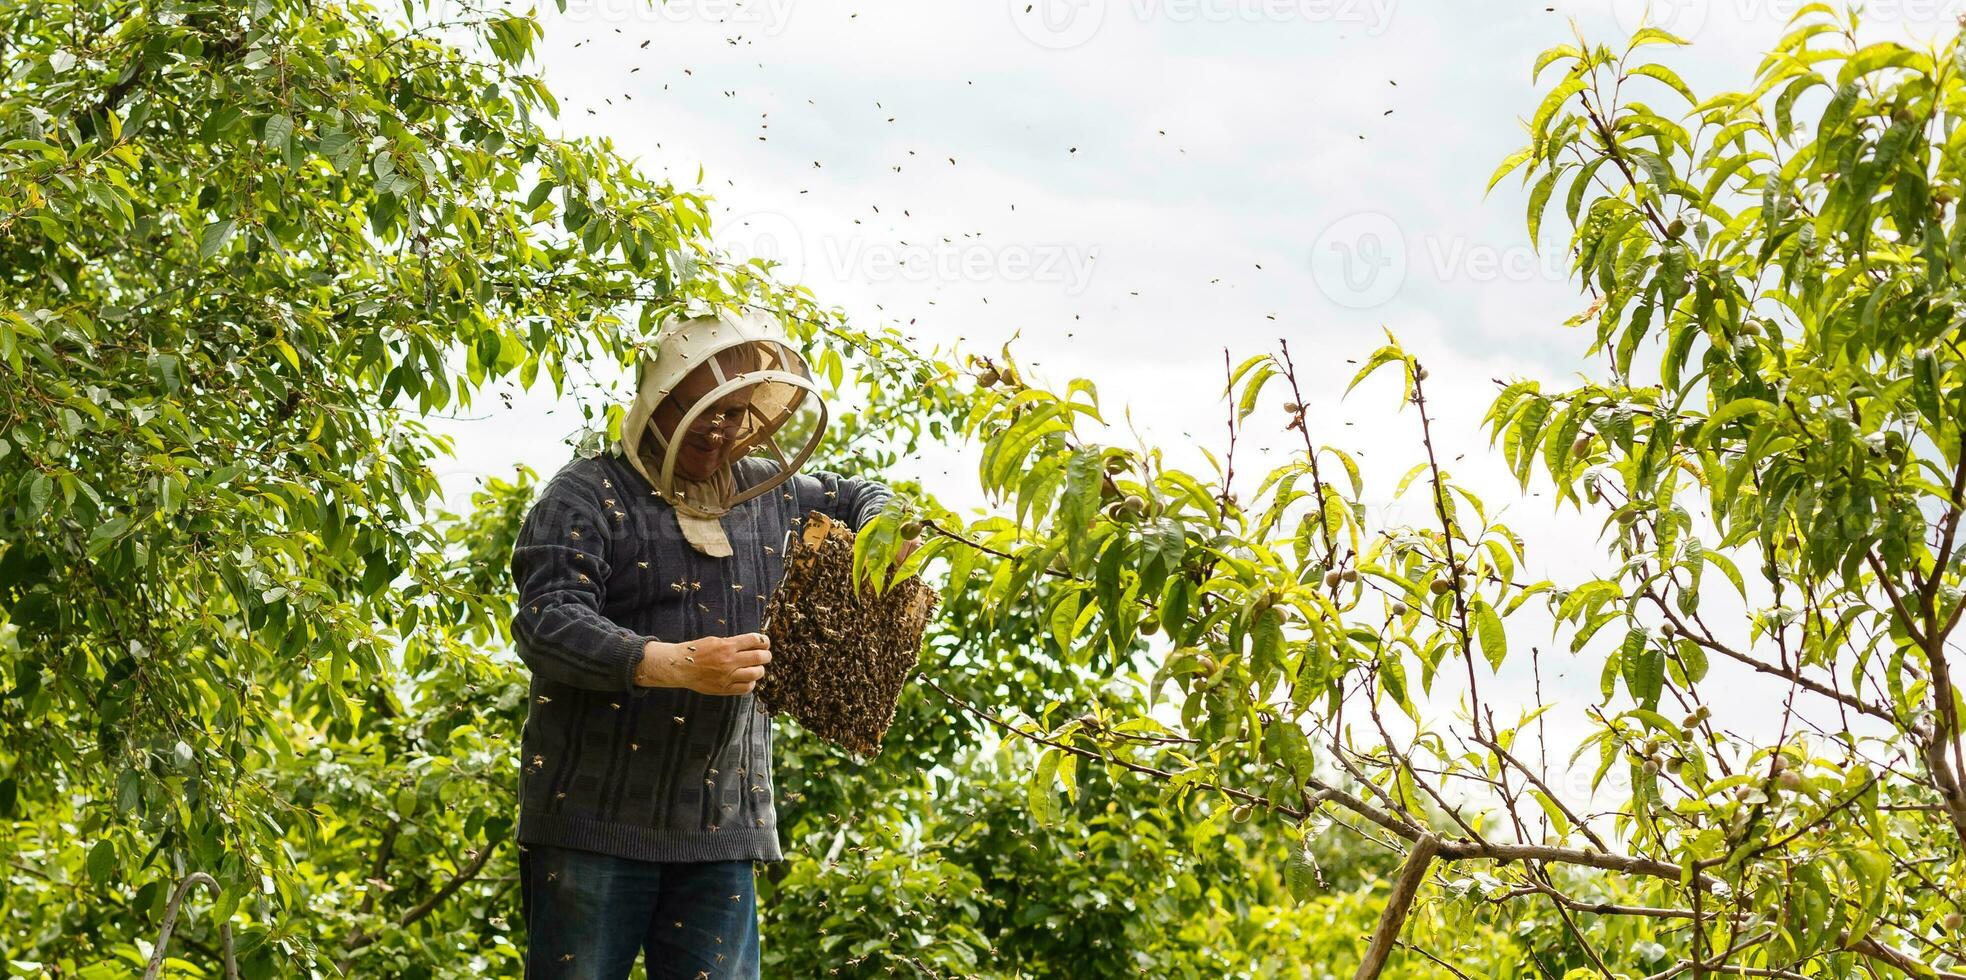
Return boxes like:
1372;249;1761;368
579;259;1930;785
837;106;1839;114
519;844;759;980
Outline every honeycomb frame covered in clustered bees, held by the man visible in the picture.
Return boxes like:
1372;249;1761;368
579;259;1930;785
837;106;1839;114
755;510;942;756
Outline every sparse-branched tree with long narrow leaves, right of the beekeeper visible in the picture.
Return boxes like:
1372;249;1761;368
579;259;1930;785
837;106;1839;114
845;4;1966;978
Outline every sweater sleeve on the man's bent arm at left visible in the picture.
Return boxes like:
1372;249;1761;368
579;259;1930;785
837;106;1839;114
511;464;651;693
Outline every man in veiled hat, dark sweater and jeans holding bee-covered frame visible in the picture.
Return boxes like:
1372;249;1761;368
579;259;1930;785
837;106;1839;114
511;313;914;980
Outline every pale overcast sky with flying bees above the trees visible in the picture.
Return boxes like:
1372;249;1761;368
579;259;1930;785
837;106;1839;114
444;0;1962;795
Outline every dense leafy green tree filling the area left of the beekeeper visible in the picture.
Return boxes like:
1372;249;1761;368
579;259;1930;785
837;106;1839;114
0;0;920;976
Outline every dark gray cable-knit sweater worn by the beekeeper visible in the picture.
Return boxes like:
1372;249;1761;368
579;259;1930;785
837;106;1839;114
511;449;891;862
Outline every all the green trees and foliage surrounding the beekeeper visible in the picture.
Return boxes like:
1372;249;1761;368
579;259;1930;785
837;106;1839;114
11;0;1966;978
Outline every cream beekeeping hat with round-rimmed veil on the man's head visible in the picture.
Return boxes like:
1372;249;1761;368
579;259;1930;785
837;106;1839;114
621;311;826;557
